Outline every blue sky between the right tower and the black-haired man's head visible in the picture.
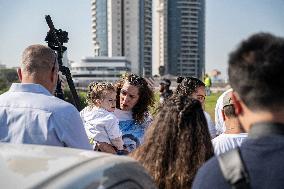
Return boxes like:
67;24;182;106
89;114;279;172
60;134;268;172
206;0;284;78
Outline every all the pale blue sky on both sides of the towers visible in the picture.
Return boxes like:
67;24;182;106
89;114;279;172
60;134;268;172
0;0;284;78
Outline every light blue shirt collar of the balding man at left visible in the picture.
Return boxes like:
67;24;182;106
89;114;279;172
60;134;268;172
9;83;53;96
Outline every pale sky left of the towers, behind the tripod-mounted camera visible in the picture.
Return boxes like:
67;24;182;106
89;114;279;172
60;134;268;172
0;0;92;67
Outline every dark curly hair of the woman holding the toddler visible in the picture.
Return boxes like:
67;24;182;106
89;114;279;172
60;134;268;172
116;74;155;123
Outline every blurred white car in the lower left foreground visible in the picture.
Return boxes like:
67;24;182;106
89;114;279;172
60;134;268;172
0;143;156;189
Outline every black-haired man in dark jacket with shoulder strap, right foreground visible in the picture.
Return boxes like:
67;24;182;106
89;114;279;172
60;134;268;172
193;33;284;189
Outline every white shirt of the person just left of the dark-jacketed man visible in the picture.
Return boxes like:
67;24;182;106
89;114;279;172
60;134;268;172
212;133;248;155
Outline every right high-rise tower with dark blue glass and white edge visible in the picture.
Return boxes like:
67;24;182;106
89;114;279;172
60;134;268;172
153;0;205;78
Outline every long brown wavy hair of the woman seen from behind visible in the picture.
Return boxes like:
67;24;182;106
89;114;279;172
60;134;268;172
130;95;214;188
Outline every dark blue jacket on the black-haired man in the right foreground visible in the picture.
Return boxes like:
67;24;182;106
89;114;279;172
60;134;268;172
192;123;284;189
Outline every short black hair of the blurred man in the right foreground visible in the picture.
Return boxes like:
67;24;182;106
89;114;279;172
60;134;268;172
228;33;284;111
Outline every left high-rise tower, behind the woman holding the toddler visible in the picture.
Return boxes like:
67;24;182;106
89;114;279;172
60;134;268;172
92;0;152;76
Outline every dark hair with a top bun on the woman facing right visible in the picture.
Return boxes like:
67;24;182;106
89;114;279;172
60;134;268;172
175;76;205;96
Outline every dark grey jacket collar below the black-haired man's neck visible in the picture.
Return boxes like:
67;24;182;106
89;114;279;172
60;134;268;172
249;122;284;138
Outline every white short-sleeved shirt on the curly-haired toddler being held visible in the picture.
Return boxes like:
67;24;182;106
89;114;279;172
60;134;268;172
80;107;122;144
